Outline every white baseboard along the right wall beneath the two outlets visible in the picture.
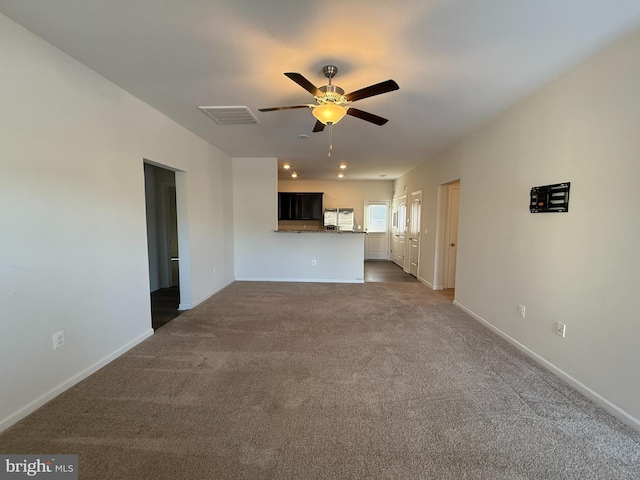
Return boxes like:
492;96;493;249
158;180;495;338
453;300;640;431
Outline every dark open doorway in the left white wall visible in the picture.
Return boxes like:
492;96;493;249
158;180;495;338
144;162;180;330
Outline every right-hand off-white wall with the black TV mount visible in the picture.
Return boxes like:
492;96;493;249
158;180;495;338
396;31;640;428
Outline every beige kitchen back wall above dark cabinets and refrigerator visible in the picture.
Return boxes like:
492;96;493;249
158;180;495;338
278;180;393;232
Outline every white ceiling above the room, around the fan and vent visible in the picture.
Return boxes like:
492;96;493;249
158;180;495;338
0;0;640;180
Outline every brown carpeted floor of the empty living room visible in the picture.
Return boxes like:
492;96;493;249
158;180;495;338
0;282;640;480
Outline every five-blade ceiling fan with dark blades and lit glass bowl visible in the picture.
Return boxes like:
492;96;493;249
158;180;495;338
258;65;400;132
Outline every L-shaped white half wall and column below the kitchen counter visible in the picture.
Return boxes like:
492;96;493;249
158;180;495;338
233;158;364;283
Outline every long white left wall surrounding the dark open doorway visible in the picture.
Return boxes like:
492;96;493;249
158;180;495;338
0;15;233;430
